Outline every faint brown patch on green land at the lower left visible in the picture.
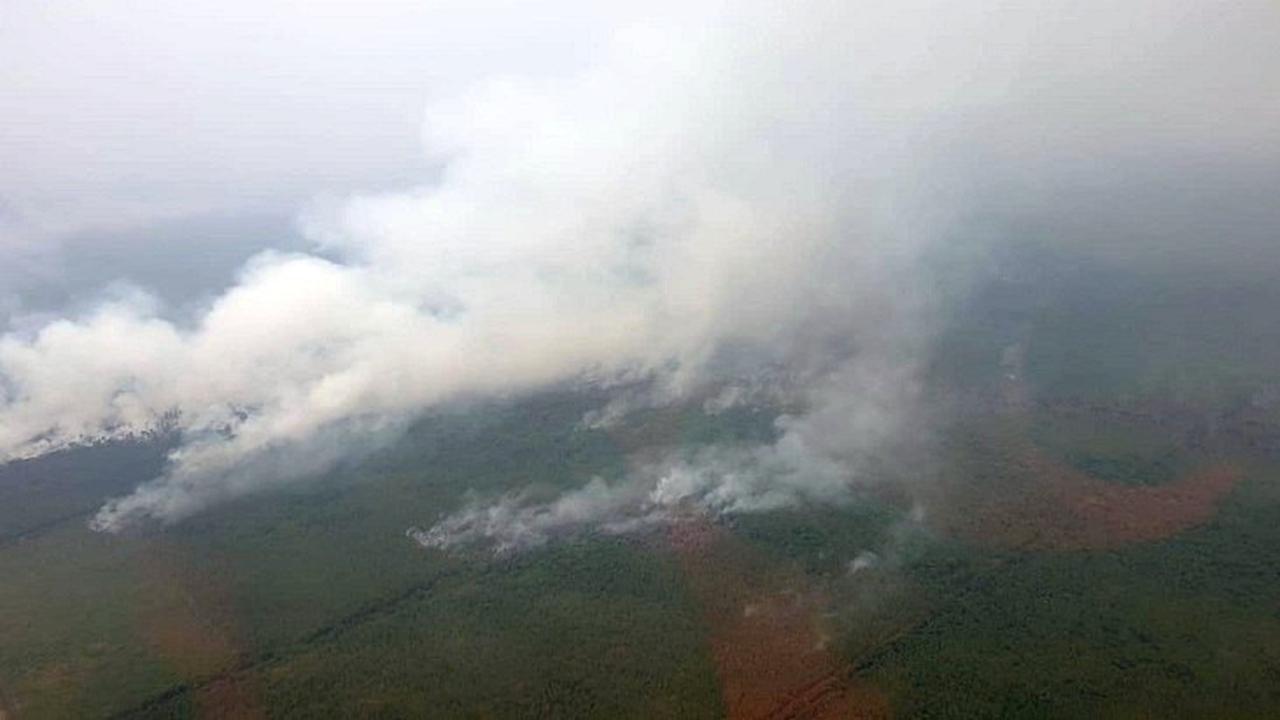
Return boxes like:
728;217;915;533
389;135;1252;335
138;541;265;717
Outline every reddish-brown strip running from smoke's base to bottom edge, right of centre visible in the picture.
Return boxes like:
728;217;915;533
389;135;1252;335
669;519;890;720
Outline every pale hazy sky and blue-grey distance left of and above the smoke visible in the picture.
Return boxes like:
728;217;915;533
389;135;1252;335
0;0;701;319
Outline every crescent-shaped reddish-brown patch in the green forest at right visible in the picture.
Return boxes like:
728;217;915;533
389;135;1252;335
934;443;1242;551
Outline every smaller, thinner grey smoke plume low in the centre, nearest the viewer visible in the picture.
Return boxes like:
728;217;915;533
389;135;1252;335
408;352;920;555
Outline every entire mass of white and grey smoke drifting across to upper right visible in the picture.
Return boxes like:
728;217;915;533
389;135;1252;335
0;0;1280;530
